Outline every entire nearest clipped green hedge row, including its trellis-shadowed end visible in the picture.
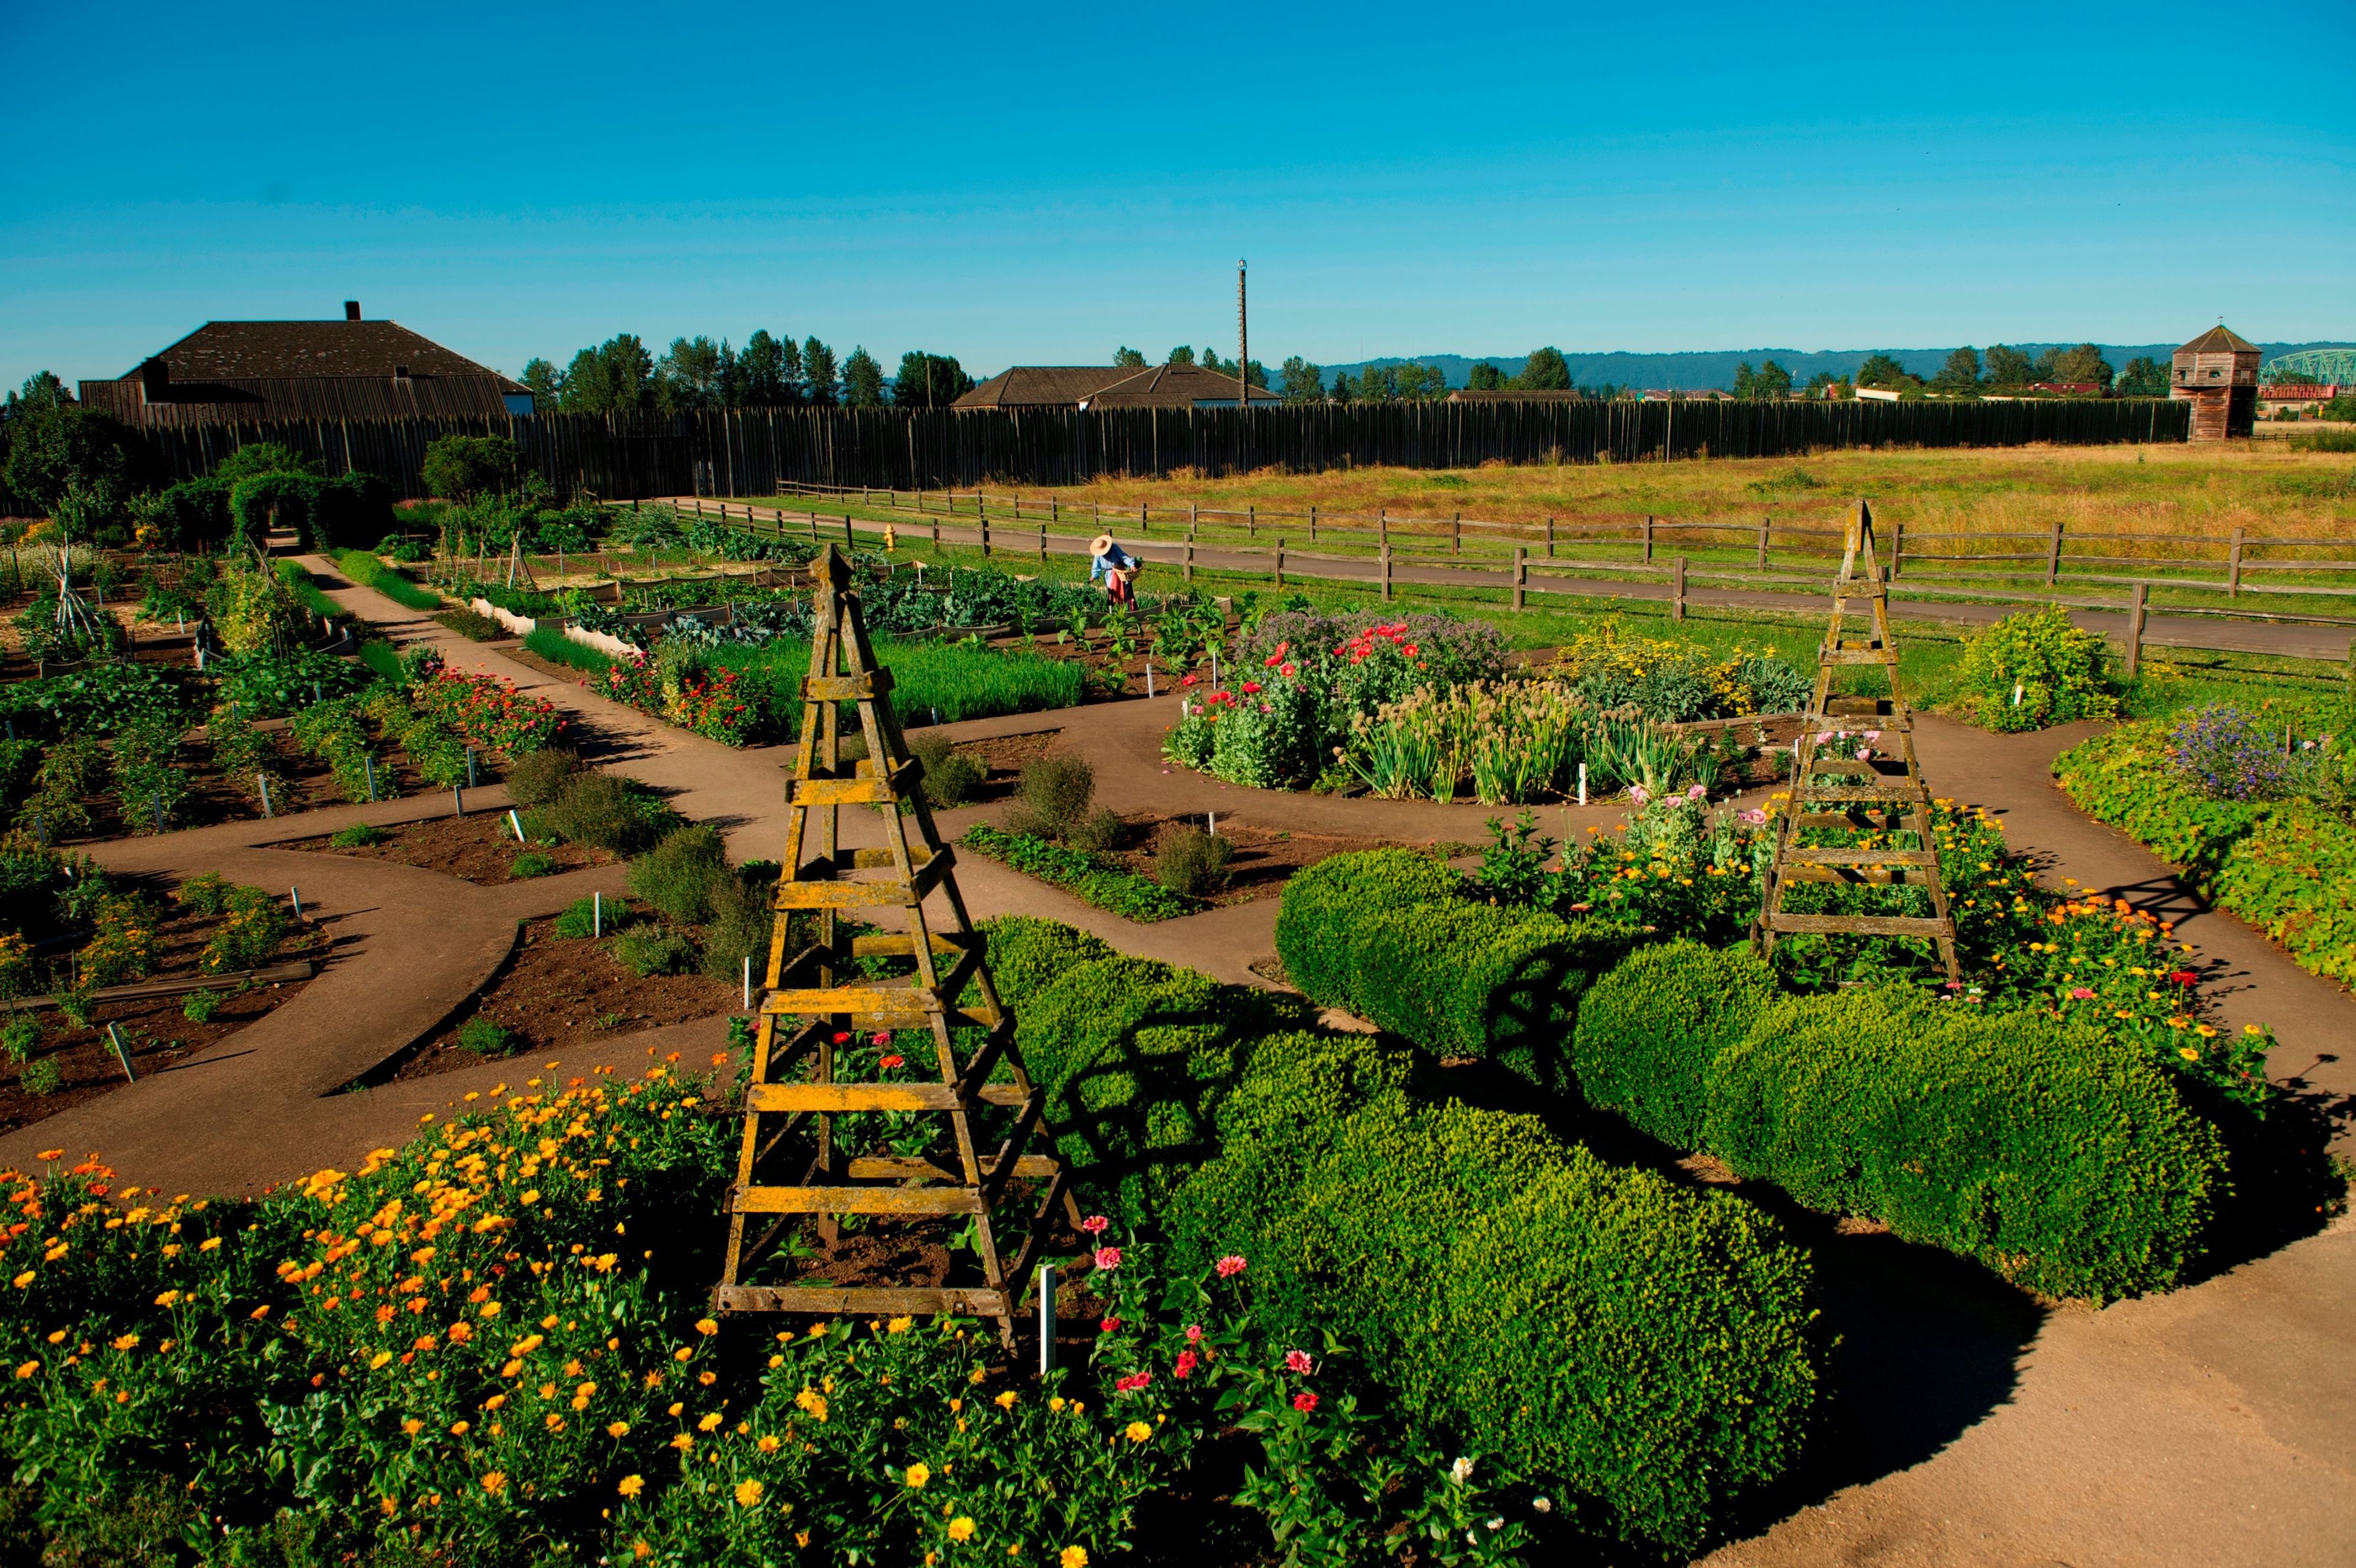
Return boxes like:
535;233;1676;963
985;918;1823;1551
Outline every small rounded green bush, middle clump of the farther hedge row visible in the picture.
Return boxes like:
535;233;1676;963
1571;942;1774;1149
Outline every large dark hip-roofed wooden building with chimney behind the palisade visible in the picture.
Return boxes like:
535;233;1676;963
82;299;535;428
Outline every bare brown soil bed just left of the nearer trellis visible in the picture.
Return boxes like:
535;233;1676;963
383;921;744;1083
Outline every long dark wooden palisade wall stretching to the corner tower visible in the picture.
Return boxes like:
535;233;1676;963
141;398;2191;499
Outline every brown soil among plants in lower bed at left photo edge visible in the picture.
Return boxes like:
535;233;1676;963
0;904;334;1132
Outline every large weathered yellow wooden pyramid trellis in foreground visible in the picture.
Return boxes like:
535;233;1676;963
714;546;1079;1344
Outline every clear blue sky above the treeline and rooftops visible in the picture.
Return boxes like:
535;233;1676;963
0;0;2356;386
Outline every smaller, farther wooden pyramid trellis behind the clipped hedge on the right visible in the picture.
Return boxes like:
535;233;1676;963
1758;501;1963;982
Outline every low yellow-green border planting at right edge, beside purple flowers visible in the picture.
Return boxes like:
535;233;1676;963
2054;718;2356;984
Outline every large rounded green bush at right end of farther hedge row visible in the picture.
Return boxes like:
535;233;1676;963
1703;986;2227;1299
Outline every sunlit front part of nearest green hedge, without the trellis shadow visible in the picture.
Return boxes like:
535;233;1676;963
1173;1092;1821;1554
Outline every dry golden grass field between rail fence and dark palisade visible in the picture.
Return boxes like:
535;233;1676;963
1017;443;2356;553
